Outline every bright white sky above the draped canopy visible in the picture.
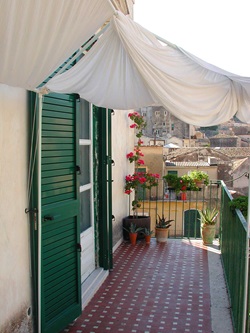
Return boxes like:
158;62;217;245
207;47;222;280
134;0;250;77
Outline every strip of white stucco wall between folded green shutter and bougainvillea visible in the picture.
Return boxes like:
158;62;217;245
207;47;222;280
112;110;134;244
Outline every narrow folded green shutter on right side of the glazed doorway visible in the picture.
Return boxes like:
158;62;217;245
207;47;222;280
93;107;113;269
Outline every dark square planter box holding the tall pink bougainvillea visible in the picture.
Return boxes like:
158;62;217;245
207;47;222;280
122;215;150;240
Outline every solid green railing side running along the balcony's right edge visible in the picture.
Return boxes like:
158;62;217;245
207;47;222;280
220;182;250;333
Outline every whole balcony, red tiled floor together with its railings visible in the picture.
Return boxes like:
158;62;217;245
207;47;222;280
63;182;250;333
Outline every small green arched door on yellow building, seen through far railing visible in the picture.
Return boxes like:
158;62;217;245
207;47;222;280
184;209;201;238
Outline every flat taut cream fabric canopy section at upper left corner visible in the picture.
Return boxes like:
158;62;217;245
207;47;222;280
0;0;113;90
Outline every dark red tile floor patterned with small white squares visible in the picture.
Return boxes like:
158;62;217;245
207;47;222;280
63;239;211;333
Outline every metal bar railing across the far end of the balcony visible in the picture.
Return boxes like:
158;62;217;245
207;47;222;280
135;180;221;238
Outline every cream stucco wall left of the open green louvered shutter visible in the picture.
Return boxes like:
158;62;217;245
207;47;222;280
0;85;31;332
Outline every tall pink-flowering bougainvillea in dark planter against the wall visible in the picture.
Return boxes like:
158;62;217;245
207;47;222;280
123;112;160;238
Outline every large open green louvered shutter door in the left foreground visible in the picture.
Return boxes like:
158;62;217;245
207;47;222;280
40;94;81;333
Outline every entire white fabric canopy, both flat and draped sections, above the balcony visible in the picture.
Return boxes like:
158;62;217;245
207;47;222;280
0;0;250;126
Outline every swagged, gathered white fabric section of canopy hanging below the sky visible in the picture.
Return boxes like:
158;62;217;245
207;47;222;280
47;13;250;126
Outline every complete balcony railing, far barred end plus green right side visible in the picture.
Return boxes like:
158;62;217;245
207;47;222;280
135;181;250;333
